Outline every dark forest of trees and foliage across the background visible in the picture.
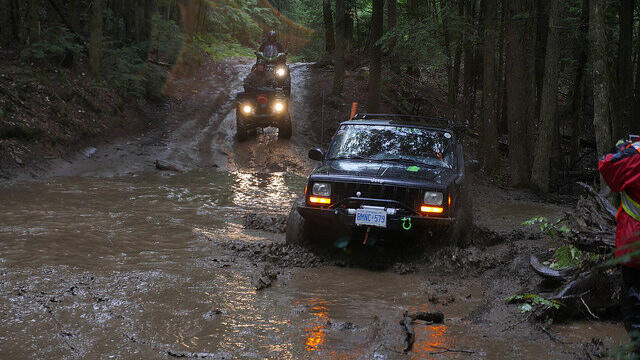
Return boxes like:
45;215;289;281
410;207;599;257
0;0;640;192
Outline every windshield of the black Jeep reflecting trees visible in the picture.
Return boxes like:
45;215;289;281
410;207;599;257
327;124;455;169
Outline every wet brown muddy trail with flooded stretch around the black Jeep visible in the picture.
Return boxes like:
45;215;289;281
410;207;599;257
0;61;626;359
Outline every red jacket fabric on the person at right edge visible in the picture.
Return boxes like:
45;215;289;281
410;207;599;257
598;143;640;269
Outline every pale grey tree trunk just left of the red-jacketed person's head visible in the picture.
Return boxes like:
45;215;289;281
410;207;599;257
589;0;613;186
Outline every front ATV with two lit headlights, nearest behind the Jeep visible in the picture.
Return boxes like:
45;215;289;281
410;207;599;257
236;88;292;141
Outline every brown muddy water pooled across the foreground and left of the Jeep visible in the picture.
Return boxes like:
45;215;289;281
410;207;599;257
0;171;622;359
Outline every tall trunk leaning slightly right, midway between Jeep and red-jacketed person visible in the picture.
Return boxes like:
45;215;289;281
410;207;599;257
531;0;560;192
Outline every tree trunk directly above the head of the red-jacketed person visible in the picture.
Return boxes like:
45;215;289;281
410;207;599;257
616;0;637;132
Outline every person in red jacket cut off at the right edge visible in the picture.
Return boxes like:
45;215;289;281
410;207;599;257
598;140;640;344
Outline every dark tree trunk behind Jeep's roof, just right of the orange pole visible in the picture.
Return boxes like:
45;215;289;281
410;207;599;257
367;0;384;113
